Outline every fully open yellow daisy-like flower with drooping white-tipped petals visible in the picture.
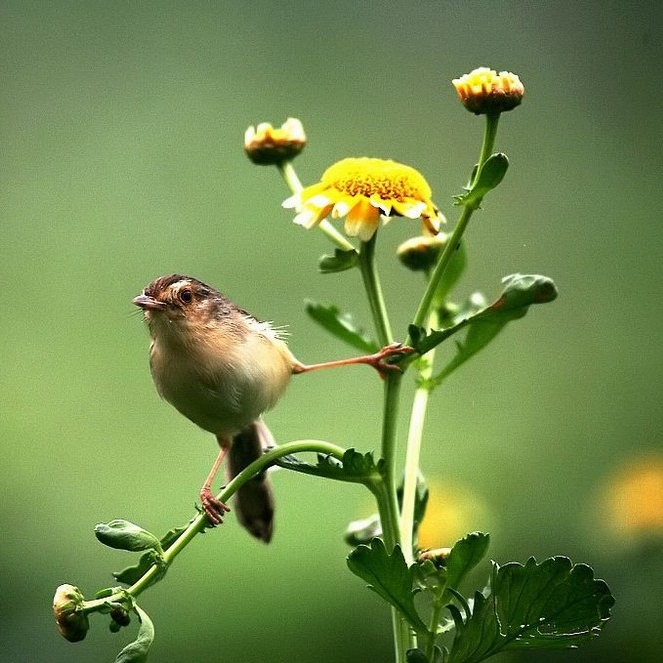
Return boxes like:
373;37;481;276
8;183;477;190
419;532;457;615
283;157;443;242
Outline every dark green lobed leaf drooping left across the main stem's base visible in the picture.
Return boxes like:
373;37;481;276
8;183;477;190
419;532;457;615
347;539;429;635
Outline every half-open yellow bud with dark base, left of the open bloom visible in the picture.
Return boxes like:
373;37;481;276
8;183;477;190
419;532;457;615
244;117;306;166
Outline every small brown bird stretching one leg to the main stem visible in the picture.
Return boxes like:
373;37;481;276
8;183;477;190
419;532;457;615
133;274;410;543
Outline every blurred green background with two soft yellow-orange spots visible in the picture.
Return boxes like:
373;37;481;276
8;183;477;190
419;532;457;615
0;0;663;663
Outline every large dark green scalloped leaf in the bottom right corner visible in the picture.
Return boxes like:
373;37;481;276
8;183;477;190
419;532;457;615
448;557;615;663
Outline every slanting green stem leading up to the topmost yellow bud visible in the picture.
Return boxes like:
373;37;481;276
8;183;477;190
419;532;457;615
405;113;500;345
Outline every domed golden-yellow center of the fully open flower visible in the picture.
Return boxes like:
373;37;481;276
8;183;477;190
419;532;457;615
322;157;431;202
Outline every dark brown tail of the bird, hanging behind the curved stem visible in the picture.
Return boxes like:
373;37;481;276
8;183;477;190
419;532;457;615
226;419;276;543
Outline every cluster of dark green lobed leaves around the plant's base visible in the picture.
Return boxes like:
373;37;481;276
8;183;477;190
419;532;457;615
348;532;614;663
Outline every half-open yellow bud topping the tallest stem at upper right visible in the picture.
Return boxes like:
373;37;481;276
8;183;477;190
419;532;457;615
451;67;525;115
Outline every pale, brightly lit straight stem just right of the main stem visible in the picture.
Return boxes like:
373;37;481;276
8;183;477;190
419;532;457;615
400;309;440;566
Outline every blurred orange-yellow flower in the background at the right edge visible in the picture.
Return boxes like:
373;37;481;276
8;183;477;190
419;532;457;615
607;457;663;534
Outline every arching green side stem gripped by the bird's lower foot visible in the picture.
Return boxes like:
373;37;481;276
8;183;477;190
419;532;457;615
83;440;345;613
